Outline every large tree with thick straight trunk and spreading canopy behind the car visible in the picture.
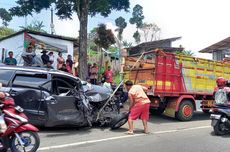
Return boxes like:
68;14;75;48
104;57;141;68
5;0;129;80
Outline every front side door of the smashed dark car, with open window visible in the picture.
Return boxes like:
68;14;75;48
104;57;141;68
46;75;87;126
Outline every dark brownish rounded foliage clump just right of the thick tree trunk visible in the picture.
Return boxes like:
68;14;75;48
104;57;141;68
94;24;116;49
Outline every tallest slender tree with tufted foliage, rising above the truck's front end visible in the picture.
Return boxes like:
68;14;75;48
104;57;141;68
129;4;145;43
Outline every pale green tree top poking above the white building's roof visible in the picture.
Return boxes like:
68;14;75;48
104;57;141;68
20;20;47;33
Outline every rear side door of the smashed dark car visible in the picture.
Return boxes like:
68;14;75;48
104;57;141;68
10;71;48;125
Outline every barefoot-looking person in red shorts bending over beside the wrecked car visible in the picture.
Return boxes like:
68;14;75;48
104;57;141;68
125;80;150;134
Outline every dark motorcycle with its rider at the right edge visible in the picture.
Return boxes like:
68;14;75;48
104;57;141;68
210;81;230;135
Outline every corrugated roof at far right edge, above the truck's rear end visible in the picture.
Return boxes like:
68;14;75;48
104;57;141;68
199;37;230;53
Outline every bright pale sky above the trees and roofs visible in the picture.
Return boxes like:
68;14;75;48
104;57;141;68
0;0;230;58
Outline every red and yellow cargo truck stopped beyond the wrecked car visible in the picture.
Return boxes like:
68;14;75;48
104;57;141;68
124;49;230;121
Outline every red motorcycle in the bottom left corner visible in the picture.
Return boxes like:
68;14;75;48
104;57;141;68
0;94;40;152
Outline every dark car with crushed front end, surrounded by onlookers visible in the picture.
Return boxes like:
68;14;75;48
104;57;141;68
0;66;127;128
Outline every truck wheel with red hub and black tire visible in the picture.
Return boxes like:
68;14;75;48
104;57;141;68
176;100;194;121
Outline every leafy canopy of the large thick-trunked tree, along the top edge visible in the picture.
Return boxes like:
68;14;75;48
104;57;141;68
10;0;129;19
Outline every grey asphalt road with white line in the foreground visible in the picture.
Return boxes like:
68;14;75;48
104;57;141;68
34;112;230;152
